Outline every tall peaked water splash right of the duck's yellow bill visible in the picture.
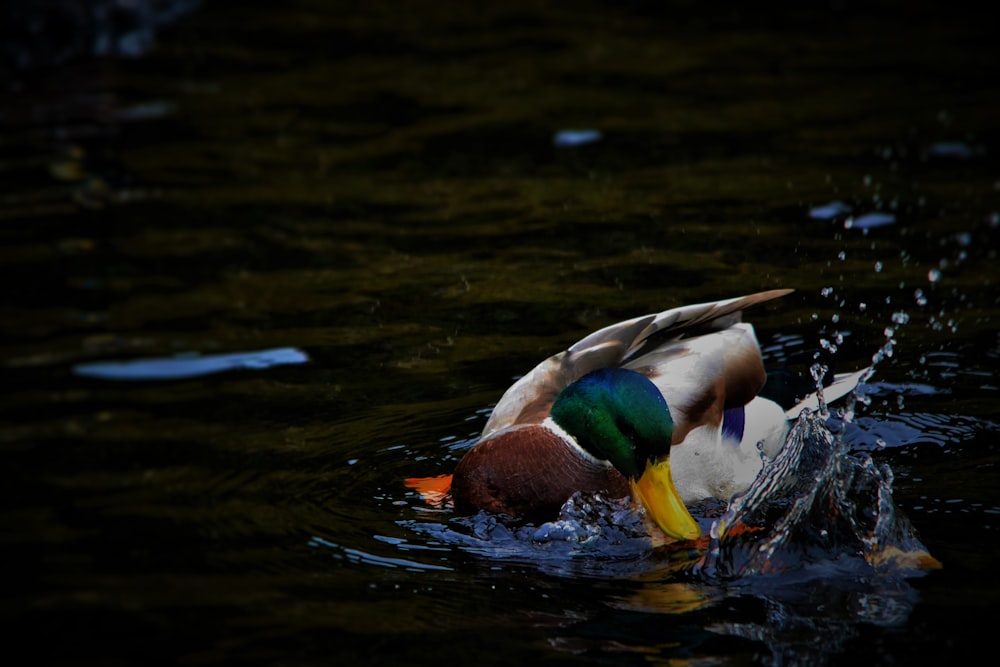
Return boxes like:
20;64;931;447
696;412;940;581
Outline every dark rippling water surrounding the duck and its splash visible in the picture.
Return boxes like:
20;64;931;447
0;0;1000;665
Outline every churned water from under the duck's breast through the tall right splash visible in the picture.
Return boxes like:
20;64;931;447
401;404;939;584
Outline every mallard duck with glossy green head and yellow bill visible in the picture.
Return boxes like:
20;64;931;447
410;289;864;540
